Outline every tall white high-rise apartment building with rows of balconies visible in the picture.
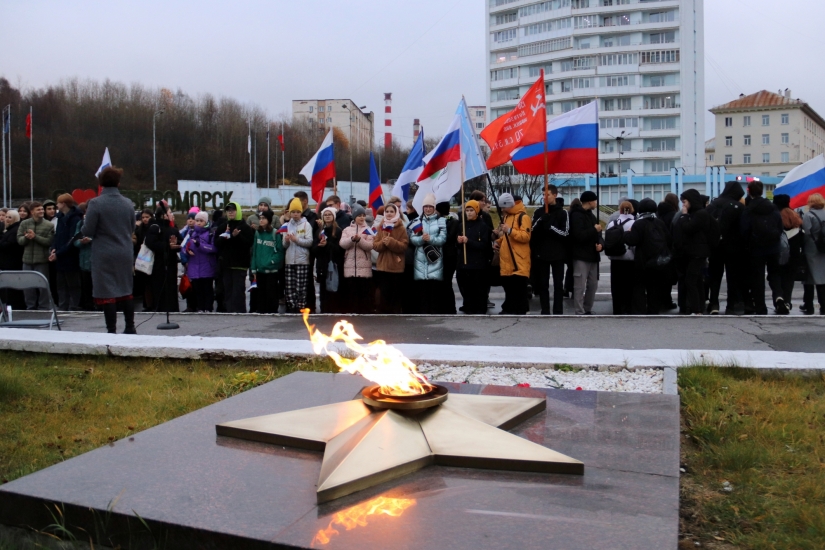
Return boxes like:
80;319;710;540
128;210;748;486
486;0;705;179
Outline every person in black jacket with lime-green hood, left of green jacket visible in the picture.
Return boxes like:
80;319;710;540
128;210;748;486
215;202;255;313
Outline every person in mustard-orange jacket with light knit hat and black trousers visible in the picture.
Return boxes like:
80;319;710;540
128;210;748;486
493;193;532;315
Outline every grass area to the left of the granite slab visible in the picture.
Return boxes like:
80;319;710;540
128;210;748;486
0;352;338;483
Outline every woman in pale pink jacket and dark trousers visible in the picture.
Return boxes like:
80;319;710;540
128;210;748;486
340;205;375;313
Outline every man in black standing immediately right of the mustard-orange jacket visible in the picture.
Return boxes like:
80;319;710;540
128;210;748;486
530;185;570;315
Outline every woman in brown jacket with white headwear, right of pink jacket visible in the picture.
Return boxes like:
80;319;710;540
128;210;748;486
373;203;410;314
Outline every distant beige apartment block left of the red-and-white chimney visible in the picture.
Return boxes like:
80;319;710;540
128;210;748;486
292;99;375;151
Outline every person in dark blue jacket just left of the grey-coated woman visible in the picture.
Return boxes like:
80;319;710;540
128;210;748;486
49;193;83;311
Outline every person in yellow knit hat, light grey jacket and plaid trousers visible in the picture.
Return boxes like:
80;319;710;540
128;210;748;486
283;198;314;313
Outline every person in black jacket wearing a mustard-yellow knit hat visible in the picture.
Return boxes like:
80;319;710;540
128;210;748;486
455;200;493;315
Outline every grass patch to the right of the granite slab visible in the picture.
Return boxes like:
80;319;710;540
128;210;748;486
679;367;825;549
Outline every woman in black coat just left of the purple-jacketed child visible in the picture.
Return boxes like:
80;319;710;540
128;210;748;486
144;208;182;311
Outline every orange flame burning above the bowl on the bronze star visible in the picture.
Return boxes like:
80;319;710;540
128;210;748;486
301;309;432;395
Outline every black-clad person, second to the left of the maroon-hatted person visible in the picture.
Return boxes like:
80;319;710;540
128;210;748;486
708;181;747;315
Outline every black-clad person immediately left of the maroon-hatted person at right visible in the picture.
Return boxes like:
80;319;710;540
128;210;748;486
740;181;790;315
